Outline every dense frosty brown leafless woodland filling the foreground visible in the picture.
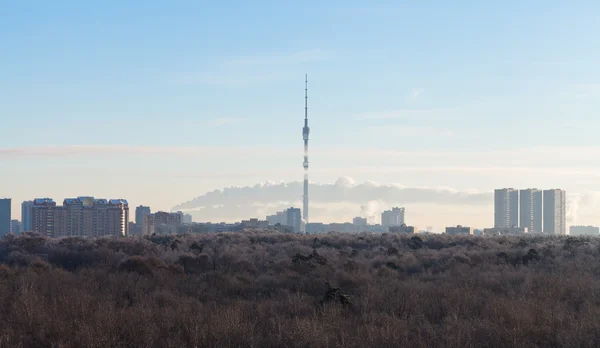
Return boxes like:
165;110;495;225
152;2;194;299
0;232;600;348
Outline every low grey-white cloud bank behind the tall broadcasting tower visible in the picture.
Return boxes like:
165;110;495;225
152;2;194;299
173;177;492;223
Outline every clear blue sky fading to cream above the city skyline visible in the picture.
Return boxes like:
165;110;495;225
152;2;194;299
0;0;600;229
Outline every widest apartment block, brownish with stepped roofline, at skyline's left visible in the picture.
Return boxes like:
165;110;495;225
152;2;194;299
31;197;129;237
